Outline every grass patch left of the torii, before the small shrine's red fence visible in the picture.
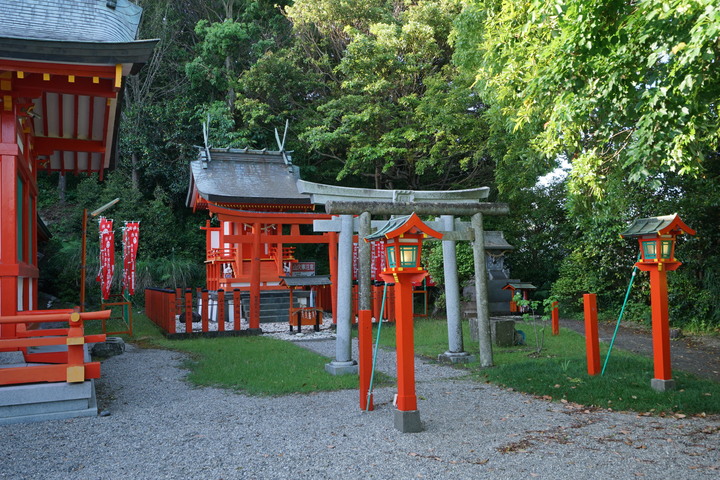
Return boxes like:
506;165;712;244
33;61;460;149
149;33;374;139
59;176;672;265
112;314;389;395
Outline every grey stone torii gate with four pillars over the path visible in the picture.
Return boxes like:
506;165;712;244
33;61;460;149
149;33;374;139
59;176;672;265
297;180;509;375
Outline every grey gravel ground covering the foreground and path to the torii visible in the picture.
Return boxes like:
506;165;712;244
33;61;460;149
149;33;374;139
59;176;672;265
0;334;720;480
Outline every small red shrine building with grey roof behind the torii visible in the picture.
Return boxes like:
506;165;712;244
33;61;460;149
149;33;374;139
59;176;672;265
187;148;338;329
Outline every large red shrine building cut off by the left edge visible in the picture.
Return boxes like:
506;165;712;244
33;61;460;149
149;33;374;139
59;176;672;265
0;0;156;416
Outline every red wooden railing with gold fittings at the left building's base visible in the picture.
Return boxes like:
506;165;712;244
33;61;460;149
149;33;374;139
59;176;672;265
0;310;110;385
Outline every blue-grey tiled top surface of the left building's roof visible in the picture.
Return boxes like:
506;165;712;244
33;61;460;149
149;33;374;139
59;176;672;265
0;0;142;43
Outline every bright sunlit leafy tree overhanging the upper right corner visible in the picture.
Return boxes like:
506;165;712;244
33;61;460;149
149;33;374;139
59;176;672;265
456;0;720;197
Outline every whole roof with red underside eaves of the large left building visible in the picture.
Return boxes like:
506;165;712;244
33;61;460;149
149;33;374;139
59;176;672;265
0;0;158;177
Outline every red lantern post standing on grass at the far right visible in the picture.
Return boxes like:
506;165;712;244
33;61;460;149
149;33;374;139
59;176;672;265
620;214;695;392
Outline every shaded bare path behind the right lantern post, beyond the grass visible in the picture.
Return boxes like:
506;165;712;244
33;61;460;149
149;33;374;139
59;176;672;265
560;319;720;382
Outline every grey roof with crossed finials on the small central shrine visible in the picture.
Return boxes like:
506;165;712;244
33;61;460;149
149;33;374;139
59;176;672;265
188;149;312;209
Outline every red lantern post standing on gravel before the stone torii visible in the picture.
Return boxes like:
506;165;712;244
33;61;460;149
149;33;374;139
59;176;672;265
365;213;442;433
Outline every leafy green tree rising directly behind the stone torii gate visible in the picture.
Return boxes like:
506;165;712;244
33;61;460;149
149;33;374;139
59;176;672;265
300;0;488;188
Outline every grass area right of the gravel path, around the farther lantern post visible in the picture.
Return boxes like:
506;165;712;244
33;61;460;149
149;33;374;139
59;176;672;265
368;319;720;414
